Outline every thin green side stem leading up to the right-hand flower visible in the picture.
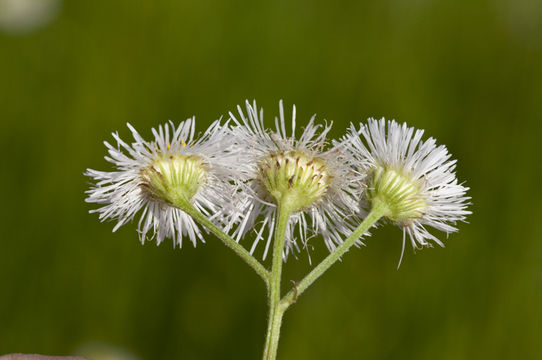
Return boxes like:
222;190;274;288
280;202;389;312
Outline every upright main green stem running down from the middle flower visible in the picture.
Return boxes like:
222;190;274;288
263;199;292;360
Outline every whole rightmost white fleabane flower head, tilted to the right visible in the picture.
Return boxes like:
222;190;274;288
343;119;471;256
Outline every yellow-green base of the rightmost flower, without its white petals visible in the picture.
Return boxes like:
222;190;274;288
367;166;427;223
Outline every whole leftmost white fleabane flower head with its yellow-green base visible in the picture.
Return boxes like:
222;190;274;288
85;118;235;246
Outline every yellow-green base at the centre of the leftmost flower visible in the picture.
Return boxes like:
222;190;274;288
141;155;207;205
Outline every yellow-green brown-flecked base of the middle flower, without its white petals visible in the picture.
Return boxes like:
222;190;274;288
259;151;330;211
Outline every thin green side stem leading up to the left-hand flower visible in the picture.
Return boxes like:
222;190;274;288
175;198;270;286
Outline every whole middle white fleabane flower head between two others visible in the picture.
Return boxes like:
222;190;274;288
230;101;362;259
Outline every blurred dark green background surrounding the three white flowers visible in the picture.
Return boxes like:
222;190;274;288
0;0;542;360
